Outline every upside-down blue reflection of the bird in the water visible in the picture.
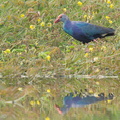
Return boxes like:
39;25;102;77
55;89;114;114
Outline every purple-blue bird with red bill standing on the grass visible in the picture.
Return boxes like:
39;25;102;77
54;14;115;44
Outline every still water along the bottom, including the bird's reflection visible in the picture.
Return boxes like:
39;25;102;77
0;77;120;120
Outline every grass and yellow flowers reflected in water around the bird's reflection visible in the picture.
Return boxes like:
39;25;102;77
0;79;120;120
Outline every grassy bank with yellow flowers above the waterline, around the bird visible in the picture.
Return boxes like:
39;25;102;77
0;0;120;77
